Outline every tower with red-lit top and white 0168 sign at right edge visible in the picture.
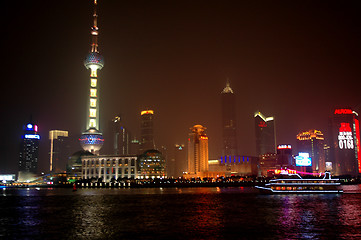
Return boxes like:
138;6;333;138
328;108;361;176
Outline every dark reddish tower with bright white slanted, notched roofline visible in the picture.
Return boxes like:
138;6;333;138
254;112;276;156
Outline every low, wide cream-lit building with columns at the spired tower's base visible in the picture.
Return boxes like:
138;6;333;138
81;155;138;182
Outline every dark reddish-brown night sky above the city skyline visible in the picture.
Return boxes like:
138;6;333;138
0;0;361;172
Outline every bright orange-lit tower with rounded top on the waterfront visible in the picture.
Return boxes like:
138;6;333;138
188;125;208;176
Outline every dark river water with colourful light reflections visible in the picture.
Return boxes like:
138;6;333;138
0;185;361;239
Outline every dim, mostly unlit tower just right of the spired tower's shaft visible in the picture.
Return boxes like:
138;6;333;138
106;116;130;155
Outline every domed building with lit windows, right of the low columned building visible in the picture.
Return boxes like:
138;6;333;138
139;149;166;179
